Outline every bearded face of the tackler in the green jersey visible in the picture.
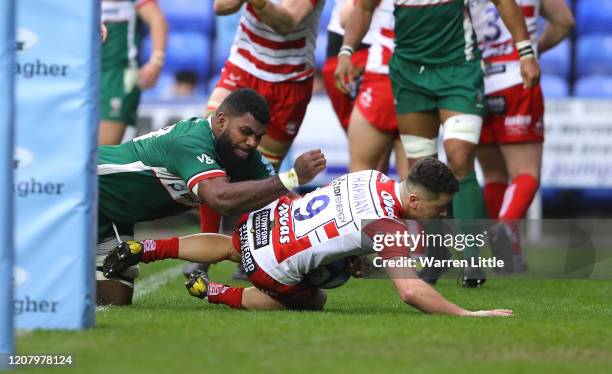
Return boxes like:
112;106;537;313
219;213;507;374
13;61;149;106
217;113;266;164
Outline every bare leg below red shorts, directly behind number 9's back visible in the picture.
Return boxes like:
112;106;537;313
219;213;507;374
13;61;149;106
348;108;393;172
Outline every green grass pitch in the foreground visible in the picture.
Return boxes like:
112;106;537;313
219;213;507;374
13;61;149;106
17;261;612;373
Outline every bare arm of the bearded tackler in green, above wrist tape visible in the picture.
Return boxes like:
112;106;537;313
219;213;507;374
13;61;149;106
197;176;287;215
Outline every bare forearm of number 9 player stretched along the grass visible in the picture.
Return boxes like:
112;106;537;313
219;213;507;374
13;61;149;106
385;262;512;317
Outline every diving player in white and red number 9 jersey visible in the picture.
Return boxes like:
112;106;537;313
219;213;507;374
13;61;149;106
104;157;512;316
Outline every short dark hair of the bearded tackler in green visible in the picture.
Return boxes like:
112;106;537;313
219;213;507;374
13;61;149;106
218;88;270;125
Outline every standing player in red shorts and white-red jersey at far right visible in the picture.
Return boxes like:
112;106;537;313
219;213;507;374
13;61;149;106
470;0;574;271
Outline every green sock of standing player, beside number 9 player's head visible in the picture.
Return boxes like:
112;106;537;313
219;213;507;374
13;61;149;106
453;171;487;258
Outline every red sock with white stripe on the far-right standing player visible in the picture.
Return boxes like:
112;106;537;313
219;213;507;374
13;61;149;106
499;174;538;220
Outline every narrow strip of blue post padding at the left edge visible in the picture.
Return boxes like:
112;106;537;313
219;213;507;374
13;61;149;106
0;0;15;368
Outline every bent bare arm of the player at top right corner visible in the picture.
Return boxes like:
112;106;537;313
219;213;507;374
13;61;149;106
538;0;576;53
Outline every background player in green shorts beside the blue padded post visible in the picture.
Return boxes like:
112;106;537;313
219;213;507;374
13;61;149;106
98;0;168;145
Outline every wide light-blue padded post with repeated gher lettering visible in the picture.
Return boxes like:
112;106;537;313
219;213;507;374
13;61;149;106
13;0;100;329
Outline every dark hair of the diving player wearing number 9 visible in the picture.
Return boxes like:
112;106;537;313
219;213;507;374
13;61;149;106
407;157;459;196
